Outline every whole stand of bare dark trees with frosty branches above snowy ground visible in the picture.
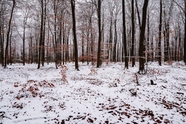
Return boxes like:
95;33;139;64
0;0;186;71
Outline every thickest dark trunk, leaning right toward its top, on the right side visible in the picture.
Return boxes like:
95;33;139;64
139;0;149;73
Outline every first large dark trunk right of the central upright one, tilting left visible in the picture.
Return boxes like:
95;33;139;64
122;0;128;69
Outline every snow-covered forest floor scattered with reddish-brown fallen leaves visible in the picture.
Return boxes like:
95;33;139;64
0;62;186;124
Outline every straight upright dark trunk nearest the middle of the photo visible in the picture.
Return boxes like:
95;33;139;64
97;0;101;68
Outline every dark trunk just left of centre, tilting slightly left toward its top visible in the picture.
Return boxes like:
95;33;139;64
71;0;79;71
